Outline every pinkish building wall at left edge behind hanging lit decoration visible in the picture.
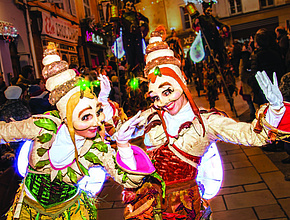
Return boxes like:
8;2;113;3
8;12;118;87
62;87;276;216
0;0;32;85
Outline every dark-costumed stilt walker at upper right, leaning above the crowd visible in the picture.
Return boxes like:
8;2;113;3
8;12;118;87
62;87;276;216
192;1;229;67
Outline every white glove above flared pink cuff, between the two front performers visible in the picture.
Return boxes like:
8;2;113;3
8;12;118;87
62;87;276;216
114;111;144;144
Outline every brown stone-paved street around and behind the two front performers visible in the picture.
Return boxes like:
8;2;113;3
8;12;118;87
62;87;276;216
99;81;290;220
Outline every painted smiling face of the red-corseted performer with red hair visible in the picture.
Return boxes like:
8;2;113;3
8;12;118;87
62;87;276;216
148;75;187;115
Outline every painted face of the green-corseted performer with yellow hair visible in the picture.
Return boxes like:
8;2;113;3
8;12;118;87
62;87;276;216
72;97;105;138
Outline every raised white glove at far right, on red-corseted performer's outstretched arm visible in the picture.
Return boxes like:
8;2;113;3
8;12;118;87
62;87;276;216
255;71;284;110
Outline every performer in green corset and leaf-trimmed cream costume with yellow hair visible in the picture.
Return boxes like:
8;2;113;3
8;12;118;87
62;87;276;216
0;45;155;220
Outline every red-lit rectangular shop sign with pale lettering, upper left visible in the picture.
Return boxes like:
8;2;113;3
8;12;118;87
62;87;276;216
42;12;79;43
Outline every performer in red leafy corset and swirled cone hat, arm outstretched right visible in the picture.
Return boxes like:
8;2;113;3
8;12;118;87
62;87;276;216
117;31;290;220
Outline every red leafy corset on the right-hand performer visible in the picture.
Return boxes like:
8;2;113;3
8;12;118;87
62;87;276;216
149;145;197;185
